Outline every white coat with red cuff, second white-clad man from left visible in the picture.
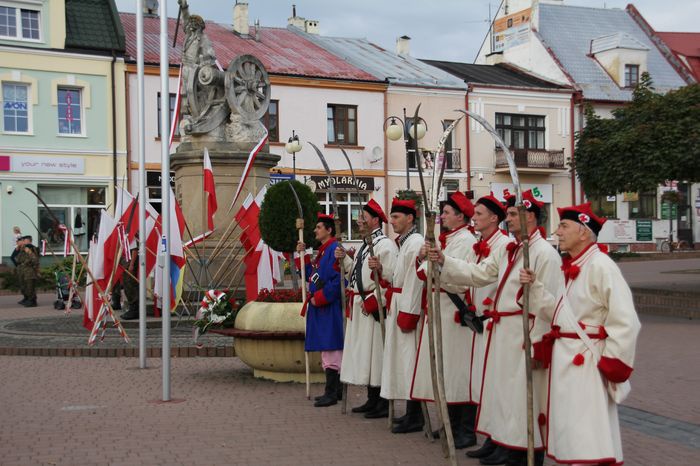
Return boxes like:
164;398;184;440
381;233;425;400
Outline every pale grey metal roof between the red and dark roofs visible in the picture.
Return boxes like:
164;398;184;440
287;26;466;90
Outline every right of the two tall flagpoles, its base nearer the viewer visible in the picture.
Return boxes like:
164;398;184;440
160;1;171;401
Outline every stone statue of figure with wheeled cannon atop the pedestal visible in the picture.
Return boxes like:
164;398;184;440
178;0;270;149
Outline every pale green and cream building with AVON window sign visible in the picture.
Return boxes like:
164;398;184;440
0;0;126;262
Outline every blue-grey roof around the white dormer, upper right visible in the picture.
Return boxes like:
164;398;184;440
538;3;685;101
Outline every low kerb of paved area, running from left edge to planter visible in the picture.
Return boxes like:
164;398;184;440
0;345;236;358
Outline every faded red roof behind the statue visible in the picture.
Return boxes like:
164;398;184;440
119;13;381;81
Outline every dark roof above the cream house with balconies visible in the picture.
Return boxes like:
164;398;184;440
422;60;565;89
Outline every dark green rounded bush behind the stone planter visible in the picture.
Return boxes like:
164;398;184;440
258;180;321;252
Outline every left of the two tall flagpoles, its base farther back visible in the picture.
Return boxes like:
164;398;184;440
136;0;146;369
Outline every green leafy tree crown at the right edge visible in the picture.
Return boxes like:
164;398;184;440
572;73;700;195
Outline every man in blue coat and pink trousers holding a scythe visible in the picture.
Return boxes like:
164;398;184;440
297;213;343;407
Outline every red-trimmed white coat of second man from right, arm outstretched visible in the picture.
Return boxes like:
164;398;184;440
441;230;564;449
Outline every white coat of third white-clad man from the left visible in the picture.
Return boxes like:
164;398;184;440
411;225;476;404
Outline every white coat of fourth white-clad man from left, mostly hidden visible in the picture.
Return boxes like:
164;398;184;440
467;229;513;404
